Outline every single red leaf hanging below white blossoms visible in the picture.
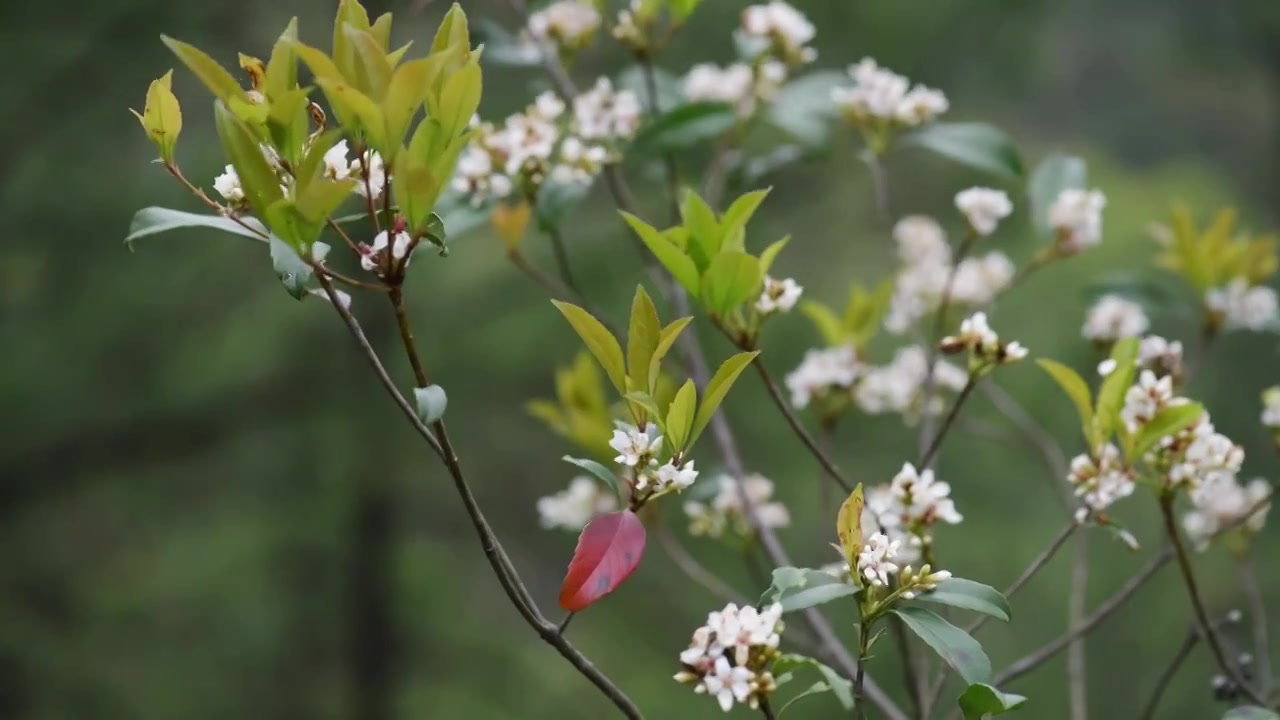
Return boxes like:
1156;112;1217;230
561;510;645;612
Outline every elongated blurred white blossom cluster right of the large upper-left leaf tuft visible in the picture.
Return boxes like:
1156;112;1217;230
453;85;641;205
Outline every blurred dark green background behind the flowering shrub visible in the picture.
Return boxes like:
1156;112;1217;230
0;0;1280;720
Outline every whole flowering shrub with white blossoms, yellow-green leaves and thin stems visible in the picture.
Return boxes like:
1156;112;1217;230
129;0;1280;720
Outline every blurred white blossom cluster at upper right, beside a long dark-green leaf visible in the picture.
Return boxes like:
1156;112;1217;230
831;58;950;127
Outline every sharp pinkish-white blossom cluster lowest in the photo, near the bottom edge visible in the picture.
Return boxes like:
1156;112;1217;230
676;603;782;712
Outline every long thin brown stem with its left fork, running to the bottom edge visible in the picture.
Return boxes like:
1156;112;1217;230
316;268;644;720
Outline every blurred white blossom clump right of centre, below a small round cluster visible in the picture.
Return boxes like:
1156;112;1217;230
884;215;1015;334
